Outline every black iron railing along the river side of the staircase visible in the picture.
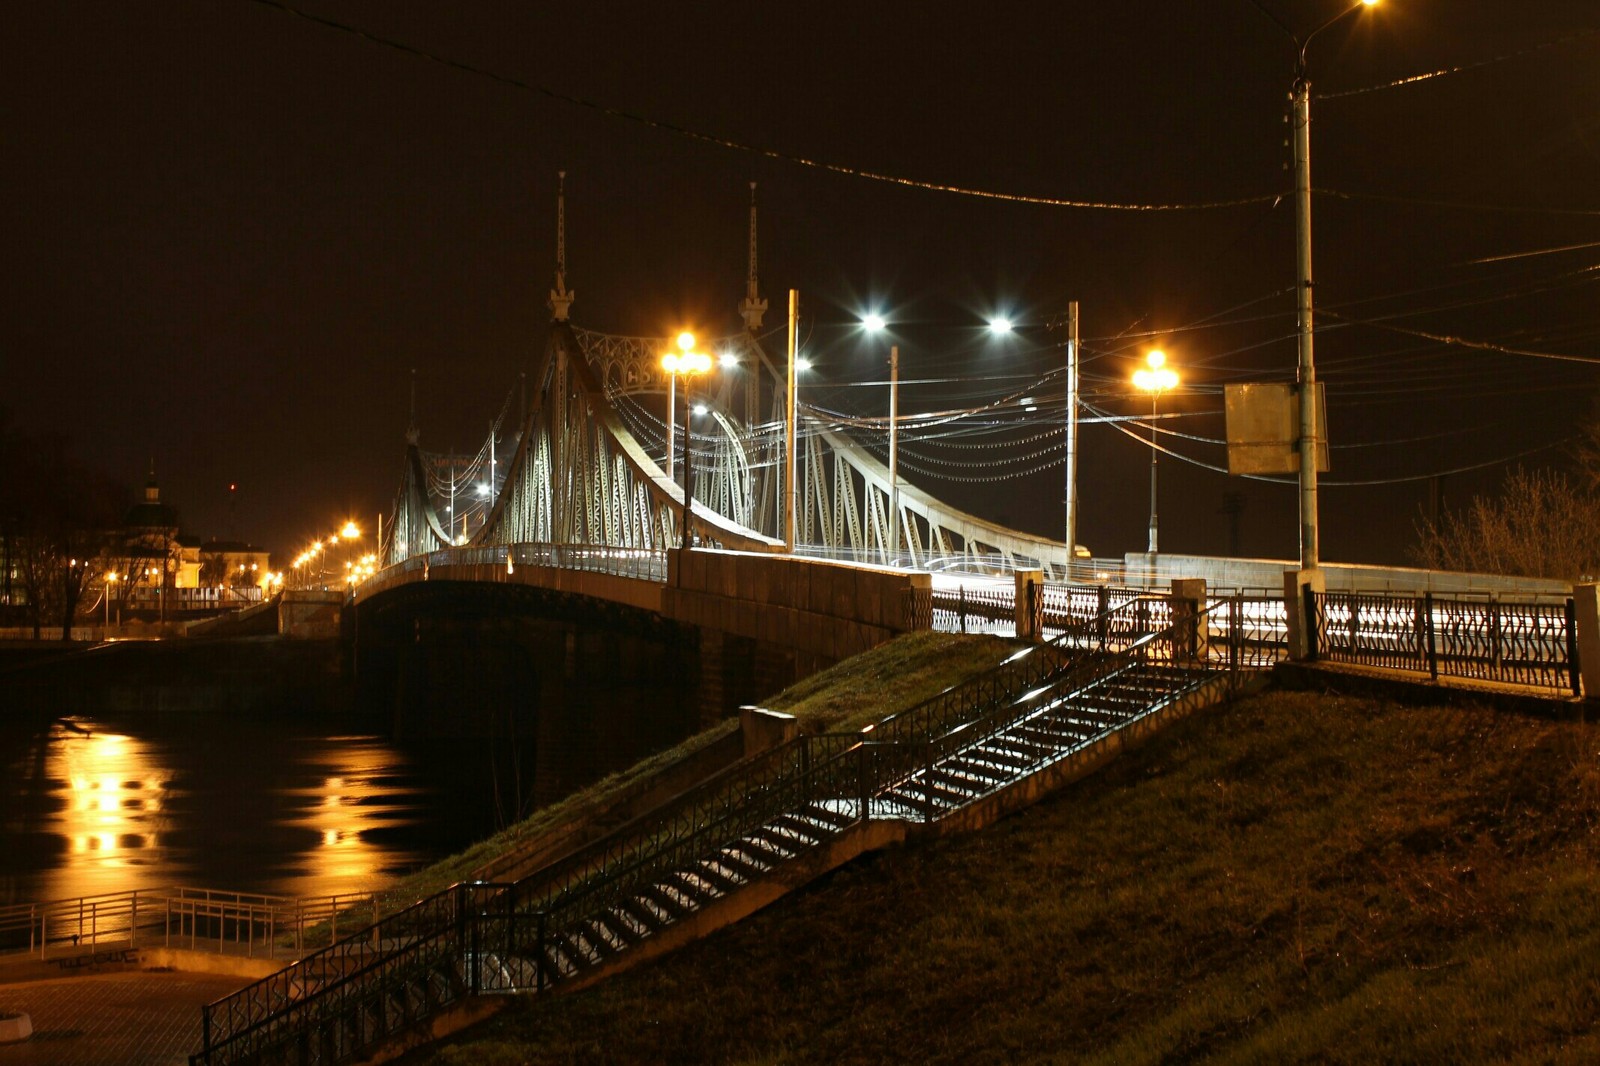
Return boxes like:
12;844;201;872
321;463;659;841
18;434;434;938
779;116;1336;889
190;603;1235;1066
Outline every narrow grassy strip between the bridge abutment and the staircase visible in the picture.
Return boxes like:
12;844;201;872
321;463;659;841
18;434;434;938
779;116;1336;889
382;632;1016;912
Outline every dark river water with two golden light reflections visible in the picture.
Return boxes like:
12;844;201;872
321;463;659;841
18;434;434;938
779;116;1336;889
0;715;533;904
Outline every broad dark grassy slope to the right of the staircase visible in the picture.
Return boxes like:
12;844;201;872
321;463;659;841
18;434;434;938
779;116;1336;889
406;693;1600;1066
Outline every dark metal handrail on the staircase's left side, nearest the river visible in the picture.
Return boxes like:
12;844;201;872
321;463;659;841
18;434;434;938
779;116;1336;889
190;600;1235;1064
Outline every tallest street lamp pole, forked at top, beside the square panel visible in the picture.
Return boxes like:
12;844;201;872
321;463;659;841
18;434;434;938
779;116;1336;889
1251;0;1378;570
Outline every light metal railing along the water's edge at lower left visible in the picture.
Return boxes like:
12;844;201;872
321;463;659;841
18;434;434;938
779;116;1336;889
0;888;376;965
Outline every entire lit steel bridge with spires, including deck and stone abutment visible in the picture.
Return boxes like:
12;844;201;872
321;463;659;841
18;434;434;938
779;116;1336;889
352;225;1094;717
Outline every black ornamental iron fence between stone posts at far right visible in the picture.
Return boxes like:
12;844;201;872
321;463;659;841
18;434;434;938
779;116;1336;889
1306;589;1582;696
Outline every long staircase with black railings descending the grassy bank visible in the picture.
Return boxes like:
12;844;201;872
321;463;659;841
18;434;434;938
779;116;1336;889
190;602;1242;1066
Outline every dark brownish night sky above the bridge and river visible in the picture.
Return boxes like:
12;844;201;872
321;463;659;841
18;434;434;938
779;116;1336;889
0;0;1600;562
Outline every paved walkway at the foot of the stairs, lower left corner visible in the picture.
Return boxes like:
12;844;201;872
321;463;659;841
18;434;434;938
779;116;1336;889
0;970;250;1066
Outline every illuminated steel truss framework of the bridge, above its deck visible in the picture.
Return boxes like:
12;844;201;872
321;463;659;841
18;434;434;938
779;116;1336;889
382;317;1072;579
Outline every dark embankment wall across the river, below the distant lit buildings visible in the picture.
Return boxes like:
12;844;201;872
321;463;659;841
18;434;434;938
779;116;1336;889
0;637;350;715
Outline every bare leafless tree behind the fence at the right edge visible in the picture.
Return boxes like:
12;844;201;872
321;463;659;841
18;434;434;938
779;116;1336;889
1416;467;1600;581
